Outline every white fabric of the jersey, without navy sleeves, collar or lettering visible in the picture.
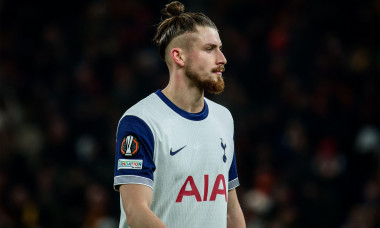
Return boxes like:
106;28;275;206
120;91;239;228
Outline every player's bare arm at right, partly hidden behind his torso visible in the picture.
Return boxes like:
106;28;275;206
227;189;246;228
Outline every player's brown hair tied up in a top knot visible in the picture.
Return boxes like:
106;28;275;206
153;1;217;60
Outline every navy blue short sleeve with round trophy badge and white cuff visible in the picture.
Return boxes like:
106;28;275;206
114;115;156;191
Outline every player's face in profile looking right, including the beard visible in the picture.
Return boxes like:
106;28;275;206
185;26;227;94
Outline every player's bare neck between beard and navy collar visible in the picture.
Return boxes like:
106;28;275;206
162;72;204;113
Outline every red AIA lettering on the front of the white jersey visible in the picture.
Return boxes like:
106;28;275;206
175;174;227;203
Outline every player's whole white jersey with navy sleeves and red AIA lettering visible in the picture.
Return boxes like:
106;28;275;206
114;90;239;228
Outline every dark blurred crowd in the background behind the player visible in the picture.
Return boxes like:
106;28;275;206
0;0;380;228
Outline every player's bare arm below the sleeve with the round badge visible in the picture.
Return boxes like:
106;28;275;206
120;184;166;228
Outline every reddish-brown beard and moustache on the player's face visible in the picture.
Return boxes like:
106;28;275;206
185;64;224;94
